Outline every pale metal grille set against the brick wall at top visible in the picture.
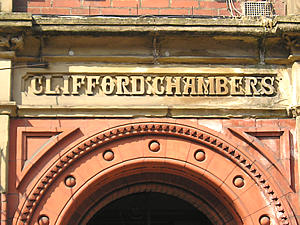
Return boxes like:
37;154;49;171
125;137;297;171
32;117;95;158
244;1;272;17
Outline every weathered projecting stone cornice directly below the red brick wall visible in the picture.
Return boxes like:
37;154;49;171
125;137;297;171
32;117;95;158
0;12;300;36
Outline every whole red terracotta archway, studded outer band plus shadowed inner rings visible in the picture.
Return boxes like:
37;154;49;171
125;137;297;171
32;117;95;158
14;123;293;225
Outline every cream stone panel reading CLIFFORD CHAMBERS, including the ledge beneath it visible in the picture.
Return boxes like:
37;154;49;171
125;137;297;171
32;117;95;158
13;64;292;116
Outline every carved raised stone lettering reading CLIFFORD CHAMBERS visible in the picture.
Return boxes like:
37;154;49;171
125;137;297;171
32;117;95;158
25;74;276;97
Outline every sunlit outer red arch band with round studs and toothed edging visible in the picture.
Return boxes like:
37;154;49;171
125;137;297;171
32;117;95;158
14;122;296;224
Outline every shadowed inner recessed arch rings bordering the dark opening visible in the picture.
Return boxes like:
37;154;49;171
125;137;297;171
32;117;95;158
55;160;243;225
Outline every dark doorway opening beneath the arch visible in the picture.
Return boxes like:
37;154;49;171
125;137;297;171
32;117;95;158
87;192;213;225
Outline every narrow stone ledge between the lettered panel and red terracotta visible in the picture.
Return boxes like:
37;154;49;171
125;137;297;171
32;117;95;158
16;105;291;118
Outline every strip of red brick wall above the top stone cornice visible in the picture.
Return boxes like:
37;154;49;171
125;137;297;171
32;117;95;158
14;0;285;16
